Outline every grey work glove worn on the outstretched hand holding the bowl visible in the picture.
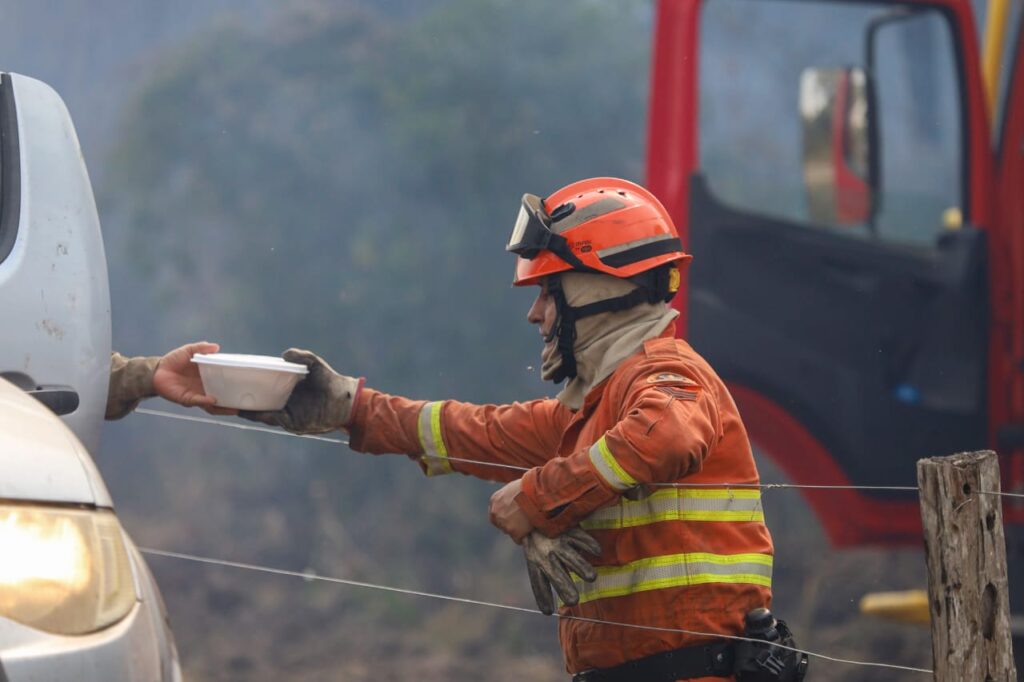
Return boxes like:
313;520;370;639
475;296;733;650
239;348;359;433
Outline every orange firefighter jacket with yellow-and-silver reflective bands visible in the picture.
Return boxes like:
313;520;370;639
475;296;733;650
349;325;772;673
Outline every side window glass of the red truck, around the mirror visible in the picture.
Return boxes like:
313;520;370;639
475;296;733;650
699;0;966;247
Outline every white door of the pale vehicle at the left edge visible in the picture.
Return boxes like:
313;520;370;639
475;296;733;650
0;74;111;453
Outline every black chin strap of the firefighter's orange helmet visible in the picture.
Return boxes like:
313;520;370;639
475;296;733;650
544;268;673;384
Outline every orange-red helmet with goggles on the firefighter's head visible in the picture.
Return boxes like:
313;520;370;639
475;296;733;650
506;177;691;288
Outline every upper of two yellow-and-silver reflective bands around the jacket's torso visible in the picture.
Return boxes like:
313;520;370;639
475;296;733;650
580;488;765;530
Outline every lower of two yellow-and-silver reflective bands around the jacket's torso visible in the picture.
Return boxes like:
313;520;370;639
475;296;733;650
572;552;772;604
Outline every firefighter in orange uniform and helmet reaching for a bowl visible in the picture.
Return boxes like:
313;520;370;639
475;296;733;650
243;178;782;682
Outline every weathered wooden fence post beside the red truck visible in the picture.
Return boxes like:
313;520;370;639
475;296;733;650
918;451;1024;682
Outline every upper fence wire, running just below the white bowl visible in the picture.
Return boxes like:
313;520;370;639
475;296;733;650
135;408;1024;499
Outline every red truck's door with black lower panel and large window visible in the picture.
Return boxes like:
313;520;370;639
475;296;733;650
648;0;991;545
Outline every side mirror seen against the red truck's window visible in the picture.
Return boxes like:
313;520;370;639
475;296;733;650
800;67;876;225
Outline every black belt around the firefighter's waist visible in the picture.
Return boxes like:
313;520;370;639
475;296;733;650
572;642;735;682
